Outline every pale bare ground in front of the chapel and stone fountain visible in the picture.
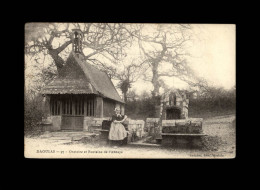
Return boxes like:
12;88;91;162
24;114;236;158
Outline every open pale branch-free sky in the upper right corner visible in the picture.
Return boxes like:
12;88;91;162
190;24;236;89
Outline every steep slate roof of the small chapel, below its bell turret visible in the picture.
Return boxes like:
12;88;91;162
41;52;124;103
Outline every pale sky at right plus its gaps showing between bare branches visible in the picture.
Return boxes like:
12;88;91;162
25;24;236;94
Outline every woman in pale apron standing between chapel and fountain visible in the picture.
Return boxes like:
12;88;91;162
108;108;127;148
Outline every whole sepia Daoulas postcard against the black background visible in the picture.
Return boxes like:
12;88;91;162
24;22;236;159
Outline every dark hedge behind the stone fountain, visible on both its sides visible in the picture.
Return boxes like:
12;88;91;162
126;87;236;119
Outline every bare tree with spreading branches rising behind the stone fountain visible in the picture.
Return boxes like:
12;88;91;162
135;24;206;96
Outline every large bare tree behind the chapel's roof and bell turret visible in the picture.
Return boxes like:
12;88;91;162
25;23;144;100
